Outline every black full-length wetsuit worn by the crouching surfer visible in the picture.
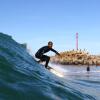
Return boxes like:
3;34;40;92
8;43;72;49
35;46;60;68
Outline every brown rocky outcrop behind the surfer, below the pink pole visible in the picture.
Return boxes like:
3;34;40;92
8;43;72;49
51;50;100;66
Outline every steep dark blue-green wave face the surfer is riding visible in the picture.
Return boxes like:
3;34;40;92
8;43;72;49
0;33;99;100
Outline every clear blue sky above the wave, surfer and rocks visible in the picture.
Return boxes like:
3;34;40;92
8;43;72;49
0;0;100;54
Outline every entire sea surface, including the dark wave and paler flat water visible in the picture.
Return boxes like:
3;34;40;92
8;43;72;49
0;33;100;100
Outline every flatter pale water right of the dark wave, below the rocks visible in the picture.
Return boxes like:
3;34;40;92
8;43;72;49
50;64;100;100
